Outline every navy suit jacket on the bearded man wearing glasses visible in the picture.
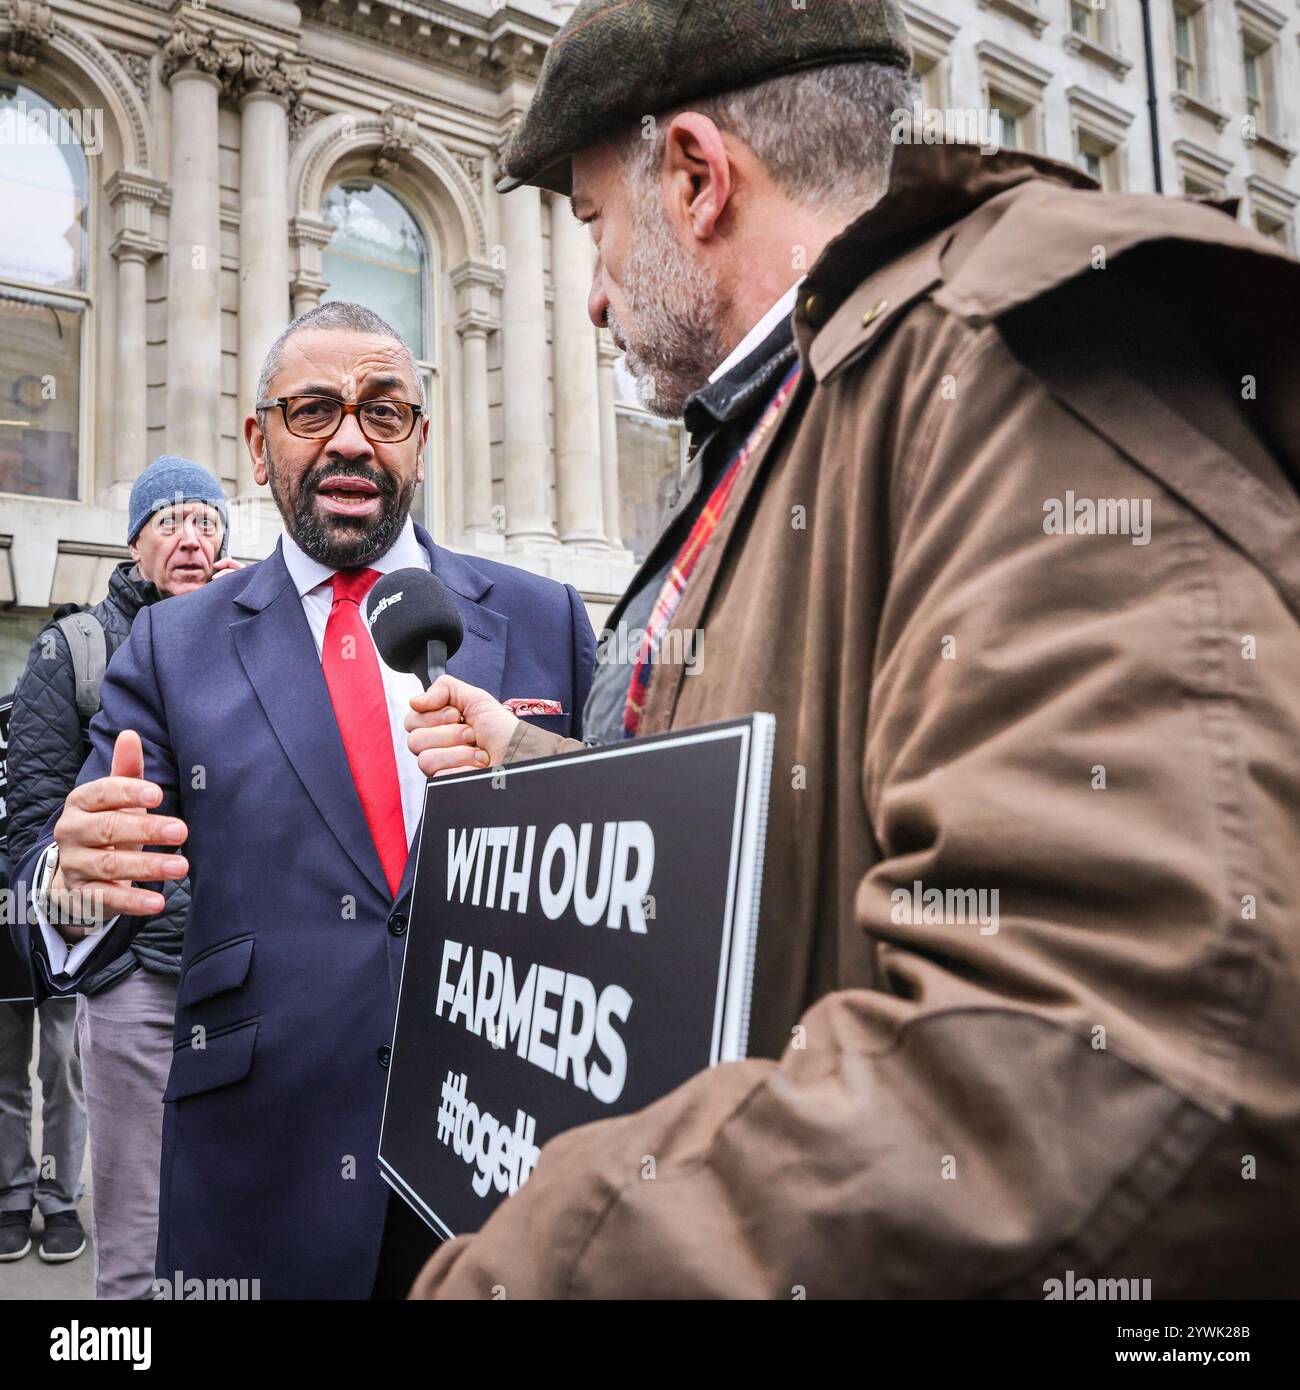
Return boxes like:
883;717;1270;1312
18;528;595;1298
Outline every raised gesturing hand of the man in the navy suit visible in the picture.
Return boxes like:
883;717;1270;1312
50;728;189;941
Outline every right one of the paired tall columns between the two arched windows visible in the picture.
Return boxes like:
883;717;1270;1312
235;55;307;496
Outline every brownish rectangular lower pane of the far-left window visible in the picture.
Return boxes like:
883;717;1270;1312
0;295;82;498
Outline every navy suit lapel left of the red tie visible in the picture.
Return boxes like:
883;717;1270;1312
231;545;389;898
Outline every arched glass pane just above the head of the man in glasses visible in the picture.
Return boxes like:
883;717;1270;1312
321;182;430;360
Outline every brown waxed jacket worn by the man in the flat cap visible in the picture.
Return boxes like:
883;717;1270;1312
413;146;1300;1298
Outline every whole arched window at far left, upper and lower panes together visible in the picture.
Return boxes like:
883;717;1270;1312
0;79;90;498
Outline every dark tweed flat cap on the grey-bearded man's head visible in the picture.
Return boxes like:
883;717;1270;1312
496;0;912;196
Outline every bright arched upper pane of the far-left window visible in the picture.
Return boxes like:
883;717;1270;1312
0;82;89;289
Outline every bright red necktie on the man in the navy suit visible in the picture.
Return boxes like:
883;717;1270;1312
321;570;407;897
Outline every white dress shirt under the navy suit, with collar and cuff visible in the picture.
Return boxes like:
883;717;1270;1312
31;517;430;976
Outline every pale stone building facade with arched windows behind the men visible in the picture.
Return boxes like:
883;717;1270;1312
0;0;1300;691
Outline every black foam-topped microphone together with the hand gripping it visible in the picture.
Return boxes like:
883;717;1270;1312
366;569;519;777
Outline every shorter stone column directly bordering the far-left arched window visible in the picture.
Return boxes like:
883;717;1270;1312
99;171;164;510
